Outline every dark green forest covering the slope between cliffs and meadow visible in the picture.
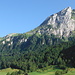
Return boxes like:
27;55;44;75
0;35;75;72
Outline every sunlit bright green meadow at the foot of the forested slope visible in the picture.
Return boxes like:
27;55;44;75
0;68;75;75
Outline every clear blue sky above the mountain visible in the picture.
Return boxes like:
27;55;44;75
0;0;75;37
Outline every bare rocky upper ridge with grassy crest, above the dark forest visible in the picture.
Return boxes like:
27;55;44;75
0;7;75;44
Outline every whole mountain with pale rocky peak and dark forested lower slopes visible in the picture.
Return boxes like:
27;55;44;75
0;7;75;71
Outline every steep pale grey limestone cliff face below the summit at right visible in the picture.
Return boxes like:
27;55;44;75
34;7;75;37
